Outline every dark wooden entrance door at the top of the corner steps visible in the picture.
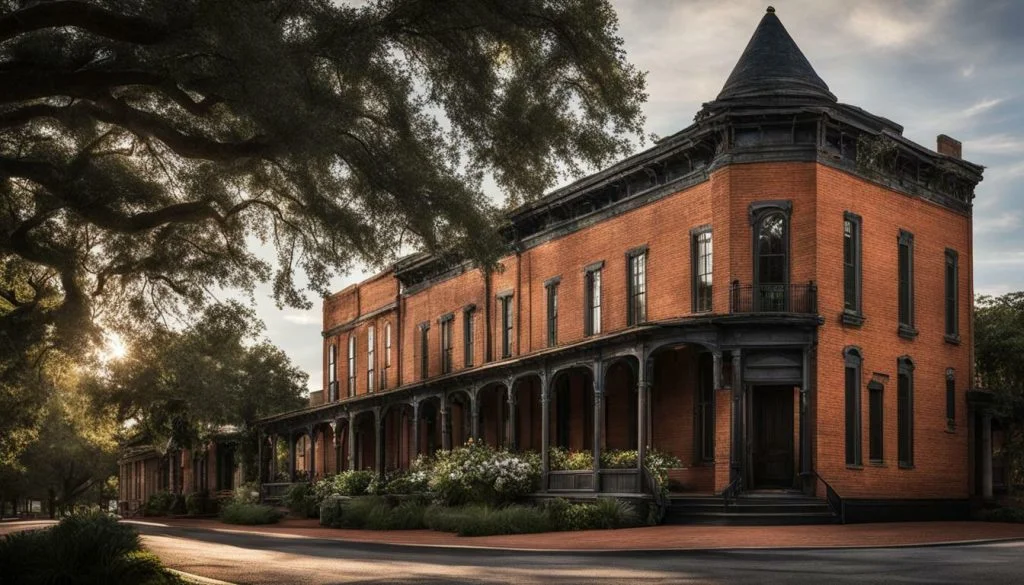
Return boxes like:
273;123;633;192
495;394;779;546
751;386;794;489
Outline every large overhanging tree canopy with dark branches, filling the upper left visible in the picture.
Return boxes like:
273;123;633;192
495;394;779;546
0;0;645;395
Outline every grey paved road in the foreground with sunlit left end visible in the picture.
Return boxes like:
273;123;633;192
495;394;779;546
130;526;1024;585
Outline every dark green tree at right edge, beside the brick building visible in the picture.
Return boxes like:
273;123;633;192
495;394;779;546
970;292;1024;490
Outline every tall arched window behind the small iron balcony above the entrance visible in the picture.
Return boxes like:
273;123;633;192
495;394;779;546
750;201;793;312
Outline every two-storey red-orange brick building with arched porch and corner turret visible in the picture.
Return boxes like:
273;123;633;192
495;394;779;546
263;8;982;518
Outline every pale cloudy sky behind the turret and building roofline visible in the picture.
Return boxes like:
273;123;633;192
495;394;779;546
245;0;1024;389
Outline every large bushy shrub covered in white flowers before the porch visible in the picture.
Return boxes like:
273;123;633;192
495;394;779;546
428;441;540;506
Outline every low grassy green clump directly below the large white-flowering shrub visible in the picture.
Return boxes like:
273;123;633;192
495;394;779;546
424;504;552;536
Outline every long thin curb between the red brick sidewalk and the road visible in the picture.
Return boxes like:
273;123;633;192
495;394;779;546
142;525;1024;555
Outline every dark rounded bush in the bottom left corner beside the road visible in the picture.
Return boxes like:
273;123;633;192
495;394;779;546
0;512;179;585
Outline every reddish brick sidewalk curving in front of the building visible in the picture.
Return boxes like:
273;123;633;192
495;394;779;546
146;518;1024;551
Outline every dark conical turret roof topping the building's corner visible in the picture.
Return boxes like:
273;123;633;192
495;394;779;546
718;6;836;101
